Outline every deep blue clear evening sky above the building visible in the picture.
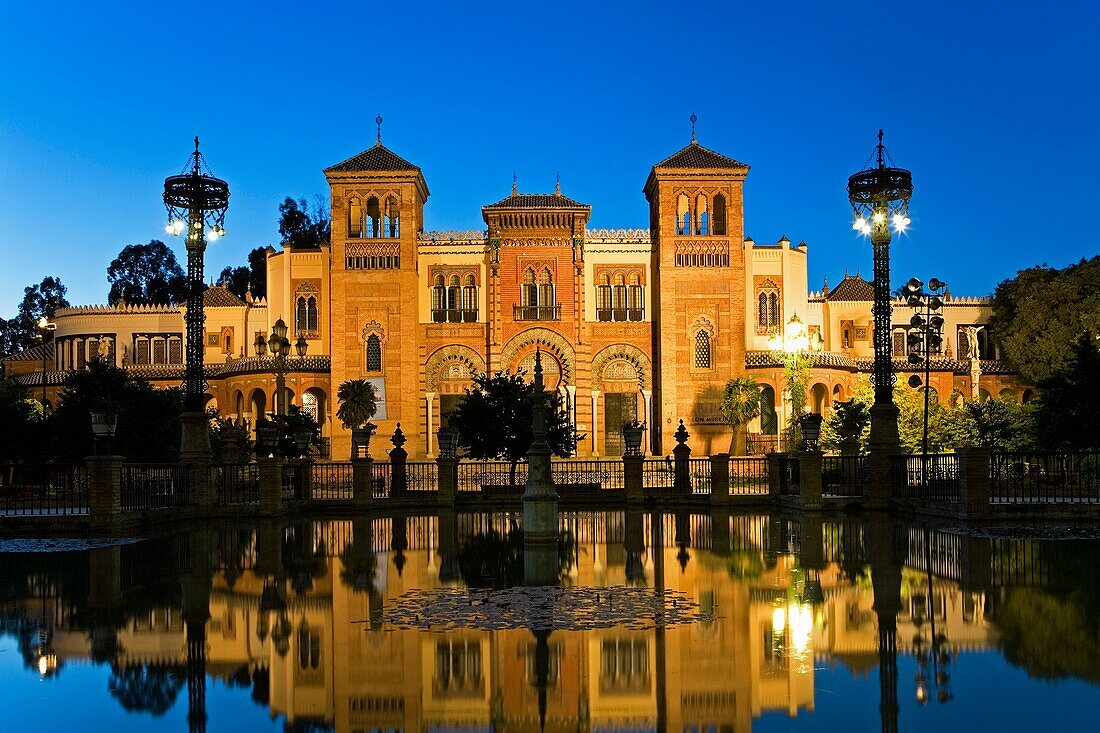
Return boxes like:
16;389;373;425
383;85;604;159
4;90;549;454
0;0;1100;316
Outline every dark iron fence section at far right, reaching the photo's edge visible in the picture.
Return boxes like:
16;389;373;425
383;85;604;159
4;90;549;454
989;451;1100;504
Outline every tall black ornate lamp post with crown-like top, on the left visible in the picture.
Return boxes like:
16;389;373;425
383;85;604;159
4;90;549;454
164;136;229;460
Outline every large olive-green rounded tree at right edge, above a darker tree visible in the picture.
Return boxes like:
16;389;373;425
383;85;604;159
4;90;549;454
989;255;1100;384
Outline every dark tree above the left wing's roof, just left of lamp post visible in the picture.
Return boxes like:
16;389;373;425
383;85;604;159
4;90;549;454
107;239;187;306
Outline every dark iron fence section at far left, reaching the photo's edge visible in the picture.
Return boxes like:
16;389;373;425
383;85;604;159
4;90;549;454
0;463;88;517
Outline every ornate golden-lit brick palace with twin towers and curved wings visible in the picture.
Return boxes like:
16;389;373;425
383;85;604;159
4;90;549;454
7;128;1031;458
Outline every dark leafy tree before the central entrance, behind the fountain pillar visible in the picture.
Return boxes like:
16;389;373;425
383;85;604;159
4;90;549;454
449;372;583;485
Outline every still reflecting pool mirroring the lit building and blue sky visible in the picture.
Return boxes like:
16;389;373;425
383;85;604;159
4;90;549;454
0;511;1100;733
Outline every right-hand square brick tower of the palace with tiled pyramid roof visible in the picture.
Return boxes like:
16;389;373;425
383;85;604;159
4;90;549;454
644;129;749;453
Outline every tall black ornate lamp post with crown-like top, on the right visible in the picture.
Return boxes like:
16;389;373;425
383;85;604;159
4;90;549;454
848;130;913;451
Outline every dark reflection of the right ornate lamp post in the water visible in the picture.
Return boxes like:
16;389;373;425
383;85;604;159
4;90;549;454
871;518;901;733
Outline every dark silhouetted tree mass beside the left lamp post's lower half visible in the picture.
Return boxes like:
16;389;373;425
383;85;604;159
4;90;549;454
46;359;184;463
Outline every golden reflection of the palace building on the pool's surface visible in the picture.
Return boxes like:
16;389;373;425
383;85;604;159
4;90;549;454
0;512;1007;732
